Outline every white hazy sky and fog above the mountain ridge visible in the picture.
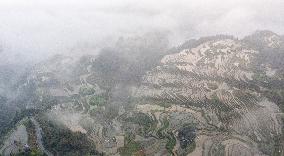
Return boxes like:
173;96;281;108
0;0;284;61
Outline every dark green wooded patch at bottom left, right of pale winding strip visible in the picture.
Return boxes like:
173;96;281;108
36;115;100;155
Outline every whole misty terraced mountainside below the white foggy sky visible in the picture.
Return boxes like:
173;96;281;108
1;31;284;156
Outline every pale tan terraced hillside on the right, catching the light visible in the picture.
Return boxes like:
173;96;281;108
134;32;283;155
